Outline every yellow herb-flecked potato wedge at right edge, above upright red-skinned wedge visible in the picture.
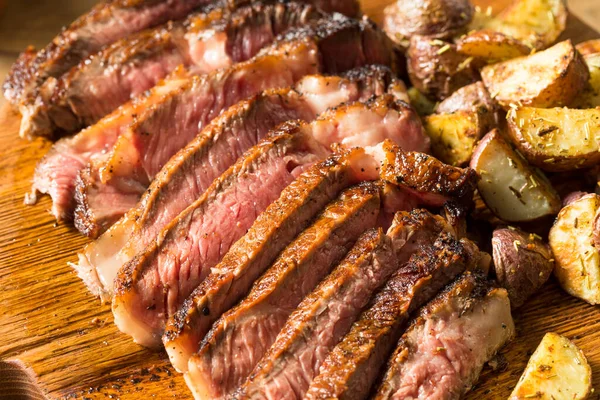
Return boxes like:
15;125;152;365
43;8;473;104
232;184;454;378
506;107;600;172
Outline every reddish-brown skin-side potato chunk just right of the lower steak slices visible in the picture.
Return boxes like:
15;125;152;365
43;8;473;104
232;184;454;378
492;228;554;309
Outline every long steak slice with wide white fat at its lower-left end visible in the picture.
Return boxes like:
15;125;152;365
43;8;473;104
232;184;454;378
78;66;406;297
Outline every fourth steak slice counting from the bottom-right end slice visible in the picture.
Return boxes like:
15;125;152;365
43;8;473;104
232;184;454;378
186;182;380;399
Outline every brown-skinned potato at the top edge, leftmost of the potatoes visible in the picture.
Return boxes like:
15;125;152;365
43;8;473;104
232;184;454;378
383;0;474;47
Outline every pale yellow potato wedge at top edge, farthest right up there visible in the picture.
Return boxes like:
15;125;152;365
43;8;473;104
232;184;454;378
470;0;568;50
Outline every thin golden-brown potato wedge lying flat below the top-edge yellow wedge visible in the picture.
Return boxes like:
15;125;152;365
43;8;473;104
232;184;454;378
456;29;531;63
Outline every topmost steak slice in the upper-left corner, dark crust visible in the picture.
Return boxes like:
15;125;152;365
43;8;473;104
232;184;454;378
4;0;210;117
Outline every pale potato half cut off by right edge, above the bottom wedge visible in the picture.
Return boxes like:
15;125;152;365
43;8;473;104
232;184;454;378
548;193;600;304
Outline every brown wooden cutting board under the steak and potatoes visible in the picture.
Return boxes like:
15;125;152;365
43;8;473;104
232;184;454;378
0;0;600;399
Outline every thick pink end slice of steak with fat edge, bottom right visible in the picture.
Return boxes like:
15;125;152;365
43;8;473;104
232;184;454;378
375;273;515;400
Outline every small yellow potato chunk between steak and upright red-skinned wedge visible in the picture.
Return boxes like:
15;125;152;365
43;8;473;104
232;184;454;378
423;110;490;166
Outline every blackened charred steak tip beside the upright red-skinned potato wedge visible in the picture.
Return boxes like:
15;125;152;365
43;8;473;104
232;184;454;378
382;143;478;202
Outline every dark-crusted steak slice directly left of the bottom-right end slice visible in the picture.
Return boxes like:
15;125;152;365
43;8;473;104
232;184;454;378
306;236;480;399
